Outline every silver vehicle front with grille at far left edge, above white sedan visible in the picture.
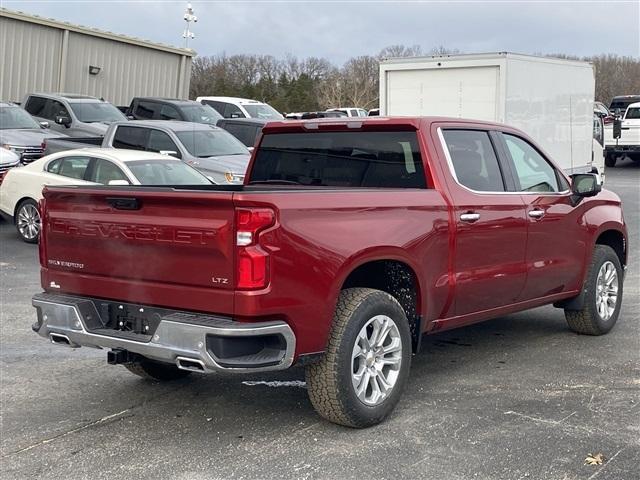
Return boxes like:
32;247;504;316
0;102;65;163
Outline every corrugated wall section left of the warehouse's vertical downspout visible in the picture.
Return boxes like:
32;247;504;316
0;17;63;102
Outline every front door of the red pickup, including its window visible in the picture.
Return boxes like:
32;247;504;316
499;129;588;301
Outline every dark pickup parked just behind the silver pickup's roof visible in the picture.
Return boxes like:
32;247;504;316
127;97;222;125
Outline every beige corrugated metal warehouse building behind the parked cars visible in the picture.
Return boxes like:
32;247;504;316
0;8;195;105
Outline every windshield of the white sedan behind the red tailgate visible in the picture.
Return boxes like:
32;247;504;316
126;159;211;185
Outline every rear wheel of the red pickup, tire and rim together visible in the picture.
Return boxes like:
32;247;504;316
305;288;411;428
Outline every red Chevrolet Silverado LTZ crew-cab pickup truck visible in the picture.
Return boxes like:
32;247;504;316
33;118;628;427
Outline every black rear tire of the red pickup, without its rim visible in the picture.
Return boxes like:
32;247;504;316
305;288;412;428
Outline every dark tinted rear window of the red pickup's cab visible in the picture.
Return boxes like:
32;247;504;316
250;131;426;188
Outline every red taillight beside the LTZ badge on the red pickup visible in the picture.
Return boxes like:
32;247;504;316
236;208;276;290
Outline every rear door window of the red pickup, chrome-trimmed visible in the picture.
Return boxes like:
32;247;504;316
442;130;505;192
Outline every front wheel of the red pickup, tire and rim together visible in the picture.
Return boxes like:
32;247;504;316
564;245;623;335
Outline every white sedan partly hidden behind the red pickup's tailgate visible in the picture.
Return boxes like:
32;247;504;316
0;148;212;243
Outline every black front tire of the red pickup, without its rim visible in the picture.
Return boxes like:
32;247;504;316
564;245;624;335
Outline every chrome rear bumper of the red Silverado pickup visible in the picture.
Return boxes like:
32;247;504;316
32;293;296;373
